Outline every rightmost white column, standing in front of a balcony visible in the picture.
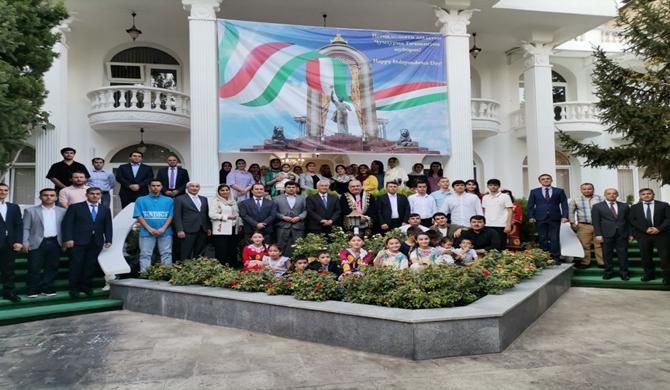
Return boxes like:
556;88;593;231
522;43;556;183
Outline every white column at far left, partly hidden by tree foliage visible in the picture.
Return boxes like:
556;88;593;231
33;19;70;195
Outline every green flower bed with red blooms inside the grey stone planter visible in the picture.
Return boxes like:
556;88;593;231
143;249;552;309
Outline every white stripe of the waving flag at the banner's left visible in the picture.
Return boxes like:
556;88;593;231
229;42;311;103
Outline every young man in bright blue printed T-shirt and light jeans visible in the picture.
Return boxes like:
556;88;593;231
133;179;174;272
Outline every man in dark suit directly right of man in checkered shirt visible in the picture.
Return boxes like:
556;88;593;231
591;188;630;280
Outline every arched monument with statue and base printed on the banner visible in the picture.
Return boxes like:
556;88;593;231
240;33;440;154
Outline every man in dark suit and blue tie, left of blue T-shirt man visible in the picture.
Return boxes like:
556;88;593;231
61;187;112;298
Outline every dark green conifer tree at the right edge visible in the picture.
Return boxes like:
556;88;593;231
559;0;670;184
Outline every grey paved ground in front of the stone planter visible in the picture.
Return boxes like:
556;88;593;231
0;288;670;390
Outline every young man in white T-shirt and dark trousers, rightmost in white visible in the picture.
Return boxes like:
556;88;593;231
482;179;514;250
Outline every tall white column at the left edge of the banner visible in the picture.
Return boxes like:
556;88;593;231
182;0;221;196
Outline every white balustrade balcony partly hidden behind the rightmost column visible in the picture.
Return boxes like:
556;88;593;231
511;102;606;141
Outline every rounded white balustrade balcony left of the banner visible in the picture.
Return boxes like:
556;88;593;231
87;85;191;131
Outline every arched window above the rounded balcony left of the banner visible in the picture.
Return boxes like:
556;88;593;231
107;46;181;90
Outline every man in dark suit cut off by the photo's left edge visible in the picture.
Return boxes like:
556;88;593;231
0;183;23;302
